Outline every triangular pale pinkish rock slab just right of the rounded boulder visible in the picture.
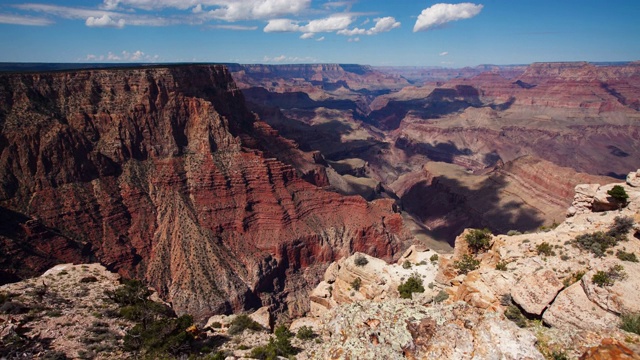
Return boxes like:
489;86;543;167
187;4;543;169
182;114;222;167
542;282;618;331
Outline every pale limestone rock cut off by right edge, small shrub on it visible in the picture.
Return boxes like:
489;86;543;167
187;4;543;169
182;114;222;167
582;261;640;314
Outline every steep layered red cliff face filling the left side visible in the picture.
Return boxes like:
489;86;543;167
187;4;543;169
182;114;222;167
0;66;403;318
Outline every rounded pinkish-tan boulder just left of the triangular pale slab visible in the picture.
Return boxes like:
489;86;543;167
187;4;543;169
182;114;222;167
511;270;563;315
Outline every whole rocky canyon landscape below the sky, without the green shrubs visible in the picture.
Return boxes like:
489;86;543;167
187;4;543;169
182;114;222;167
0;62;640;359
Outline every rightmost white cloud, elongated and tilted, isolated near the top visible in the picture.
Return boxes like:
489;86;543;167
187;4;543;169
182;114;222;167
413;3;483;32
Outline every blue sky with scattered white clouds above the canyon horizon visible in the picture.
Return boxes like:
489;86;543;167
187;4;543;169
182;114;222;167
0;0;640;67
